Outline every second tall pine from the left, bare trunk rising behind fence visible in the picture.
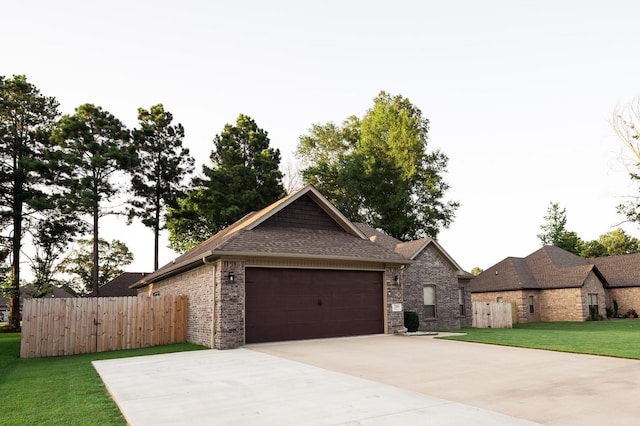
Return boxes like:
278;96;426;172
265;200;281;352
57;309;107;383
53;104;138;287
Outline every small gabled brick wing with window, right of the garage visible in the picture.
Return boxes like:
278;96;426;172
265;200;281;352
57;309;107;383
356;223;474;330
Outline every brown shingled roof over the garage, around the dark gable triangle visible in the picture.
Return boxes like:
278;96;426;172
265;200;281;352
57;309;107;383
132;185;410;288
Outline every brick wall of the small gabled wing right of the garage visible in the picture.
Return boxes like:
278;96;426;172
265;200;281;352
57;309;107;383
402;245;472;330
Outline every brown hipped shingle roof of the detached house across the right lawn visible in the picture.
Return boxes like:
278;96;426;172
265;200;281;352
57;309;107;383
471;246;607;293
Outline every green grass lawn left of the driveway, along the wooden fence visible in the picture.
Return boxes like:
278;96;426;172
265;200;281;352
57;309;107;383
0;333;204;425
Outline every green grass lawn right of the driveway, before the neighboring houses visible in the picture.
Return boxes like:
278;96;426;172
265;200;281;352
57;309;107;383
443;319;640;359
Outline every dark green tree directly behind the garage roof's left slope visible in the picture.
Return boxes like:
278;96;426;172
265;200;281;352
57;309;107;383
167;114;285;251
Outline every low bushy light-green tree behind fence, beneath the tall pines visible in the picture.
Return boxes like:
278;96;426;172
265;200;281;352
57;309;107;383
60;239;133;294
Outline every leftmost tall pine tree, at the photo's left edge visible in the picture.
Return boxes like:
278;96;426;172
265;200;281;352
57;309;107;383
0;75;59;330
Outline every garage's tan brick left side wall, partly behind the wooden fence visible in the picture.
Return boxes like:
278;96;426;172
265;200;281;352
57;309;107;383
138;265;213;348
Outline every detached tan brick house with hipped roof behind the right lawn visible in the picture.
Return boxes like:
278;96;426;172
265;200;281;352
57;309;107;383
471;246;609;323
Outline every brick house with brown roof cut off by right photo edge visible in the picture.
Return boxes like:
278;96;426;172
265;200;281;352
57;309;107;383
590;253;640;315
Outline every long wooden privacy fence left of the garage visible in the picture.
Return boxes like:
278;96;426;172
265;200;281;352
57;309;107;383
20;296;187;358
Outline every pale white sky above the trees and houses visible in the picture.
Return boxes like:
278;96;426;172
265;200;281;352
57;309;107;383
0;0;640;271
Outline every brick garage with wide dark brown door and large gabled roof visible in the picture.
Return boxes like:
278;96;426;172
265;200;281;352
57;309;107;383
133;186;412;349
